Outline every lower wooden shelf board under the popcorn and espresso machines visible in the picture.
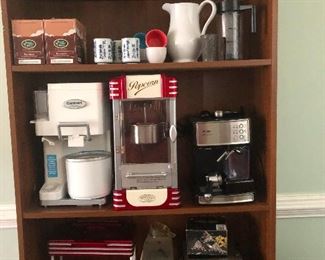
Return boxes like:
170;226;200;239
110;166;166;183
23;202;269;219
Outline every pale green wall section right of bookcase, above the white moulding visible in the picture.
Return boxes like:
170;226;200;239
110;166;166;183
277;0;325;193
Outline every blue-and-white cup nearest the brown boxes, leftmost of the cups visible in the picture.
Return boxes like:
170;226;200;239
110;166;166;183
94;38;113;64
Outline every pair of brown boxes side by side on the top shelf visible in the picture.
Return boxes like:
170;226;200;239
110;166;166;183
12;19;86;65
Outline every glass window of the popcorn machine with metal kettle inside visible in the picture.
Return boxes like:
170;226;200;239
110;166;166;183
121;99;170;163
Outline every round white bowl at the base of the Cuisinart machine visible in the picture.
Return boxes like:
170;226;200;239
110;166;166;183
65;151;112;199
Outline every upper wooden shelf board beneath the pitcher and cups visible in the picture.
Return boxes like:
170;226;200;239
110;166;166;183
12;59;272;73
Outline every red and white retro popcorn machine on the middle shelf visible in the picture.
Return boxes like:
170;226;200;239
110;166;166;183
109;74;180;210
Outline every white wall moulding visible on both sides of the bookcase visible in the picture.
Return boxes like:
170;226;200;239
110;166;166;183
0;193;325;229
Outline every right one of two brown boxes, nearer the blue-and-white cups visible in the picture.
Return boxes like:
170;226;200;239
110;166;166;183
44;19;86;64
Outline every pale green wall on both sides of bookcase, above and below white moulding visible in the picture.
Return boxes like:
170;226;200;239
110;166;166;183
0;0;325;260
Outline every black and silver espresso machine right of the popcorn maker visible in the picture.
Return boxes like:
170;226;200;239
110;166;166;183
192;111;254;204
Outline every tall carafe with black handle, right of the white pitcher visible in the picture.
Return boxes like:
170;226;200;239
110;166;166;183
216;0;256;60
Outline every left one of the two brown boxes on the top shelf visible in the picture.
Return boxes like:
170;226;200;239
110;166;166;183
11;20;45;64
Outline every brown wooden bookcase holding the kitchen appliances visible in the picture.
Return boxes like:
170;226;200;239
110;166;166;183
1;0;277;260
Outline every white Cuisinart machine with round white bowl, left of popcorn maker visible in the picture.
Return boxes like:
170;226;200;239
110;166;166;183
31;83;112;206
